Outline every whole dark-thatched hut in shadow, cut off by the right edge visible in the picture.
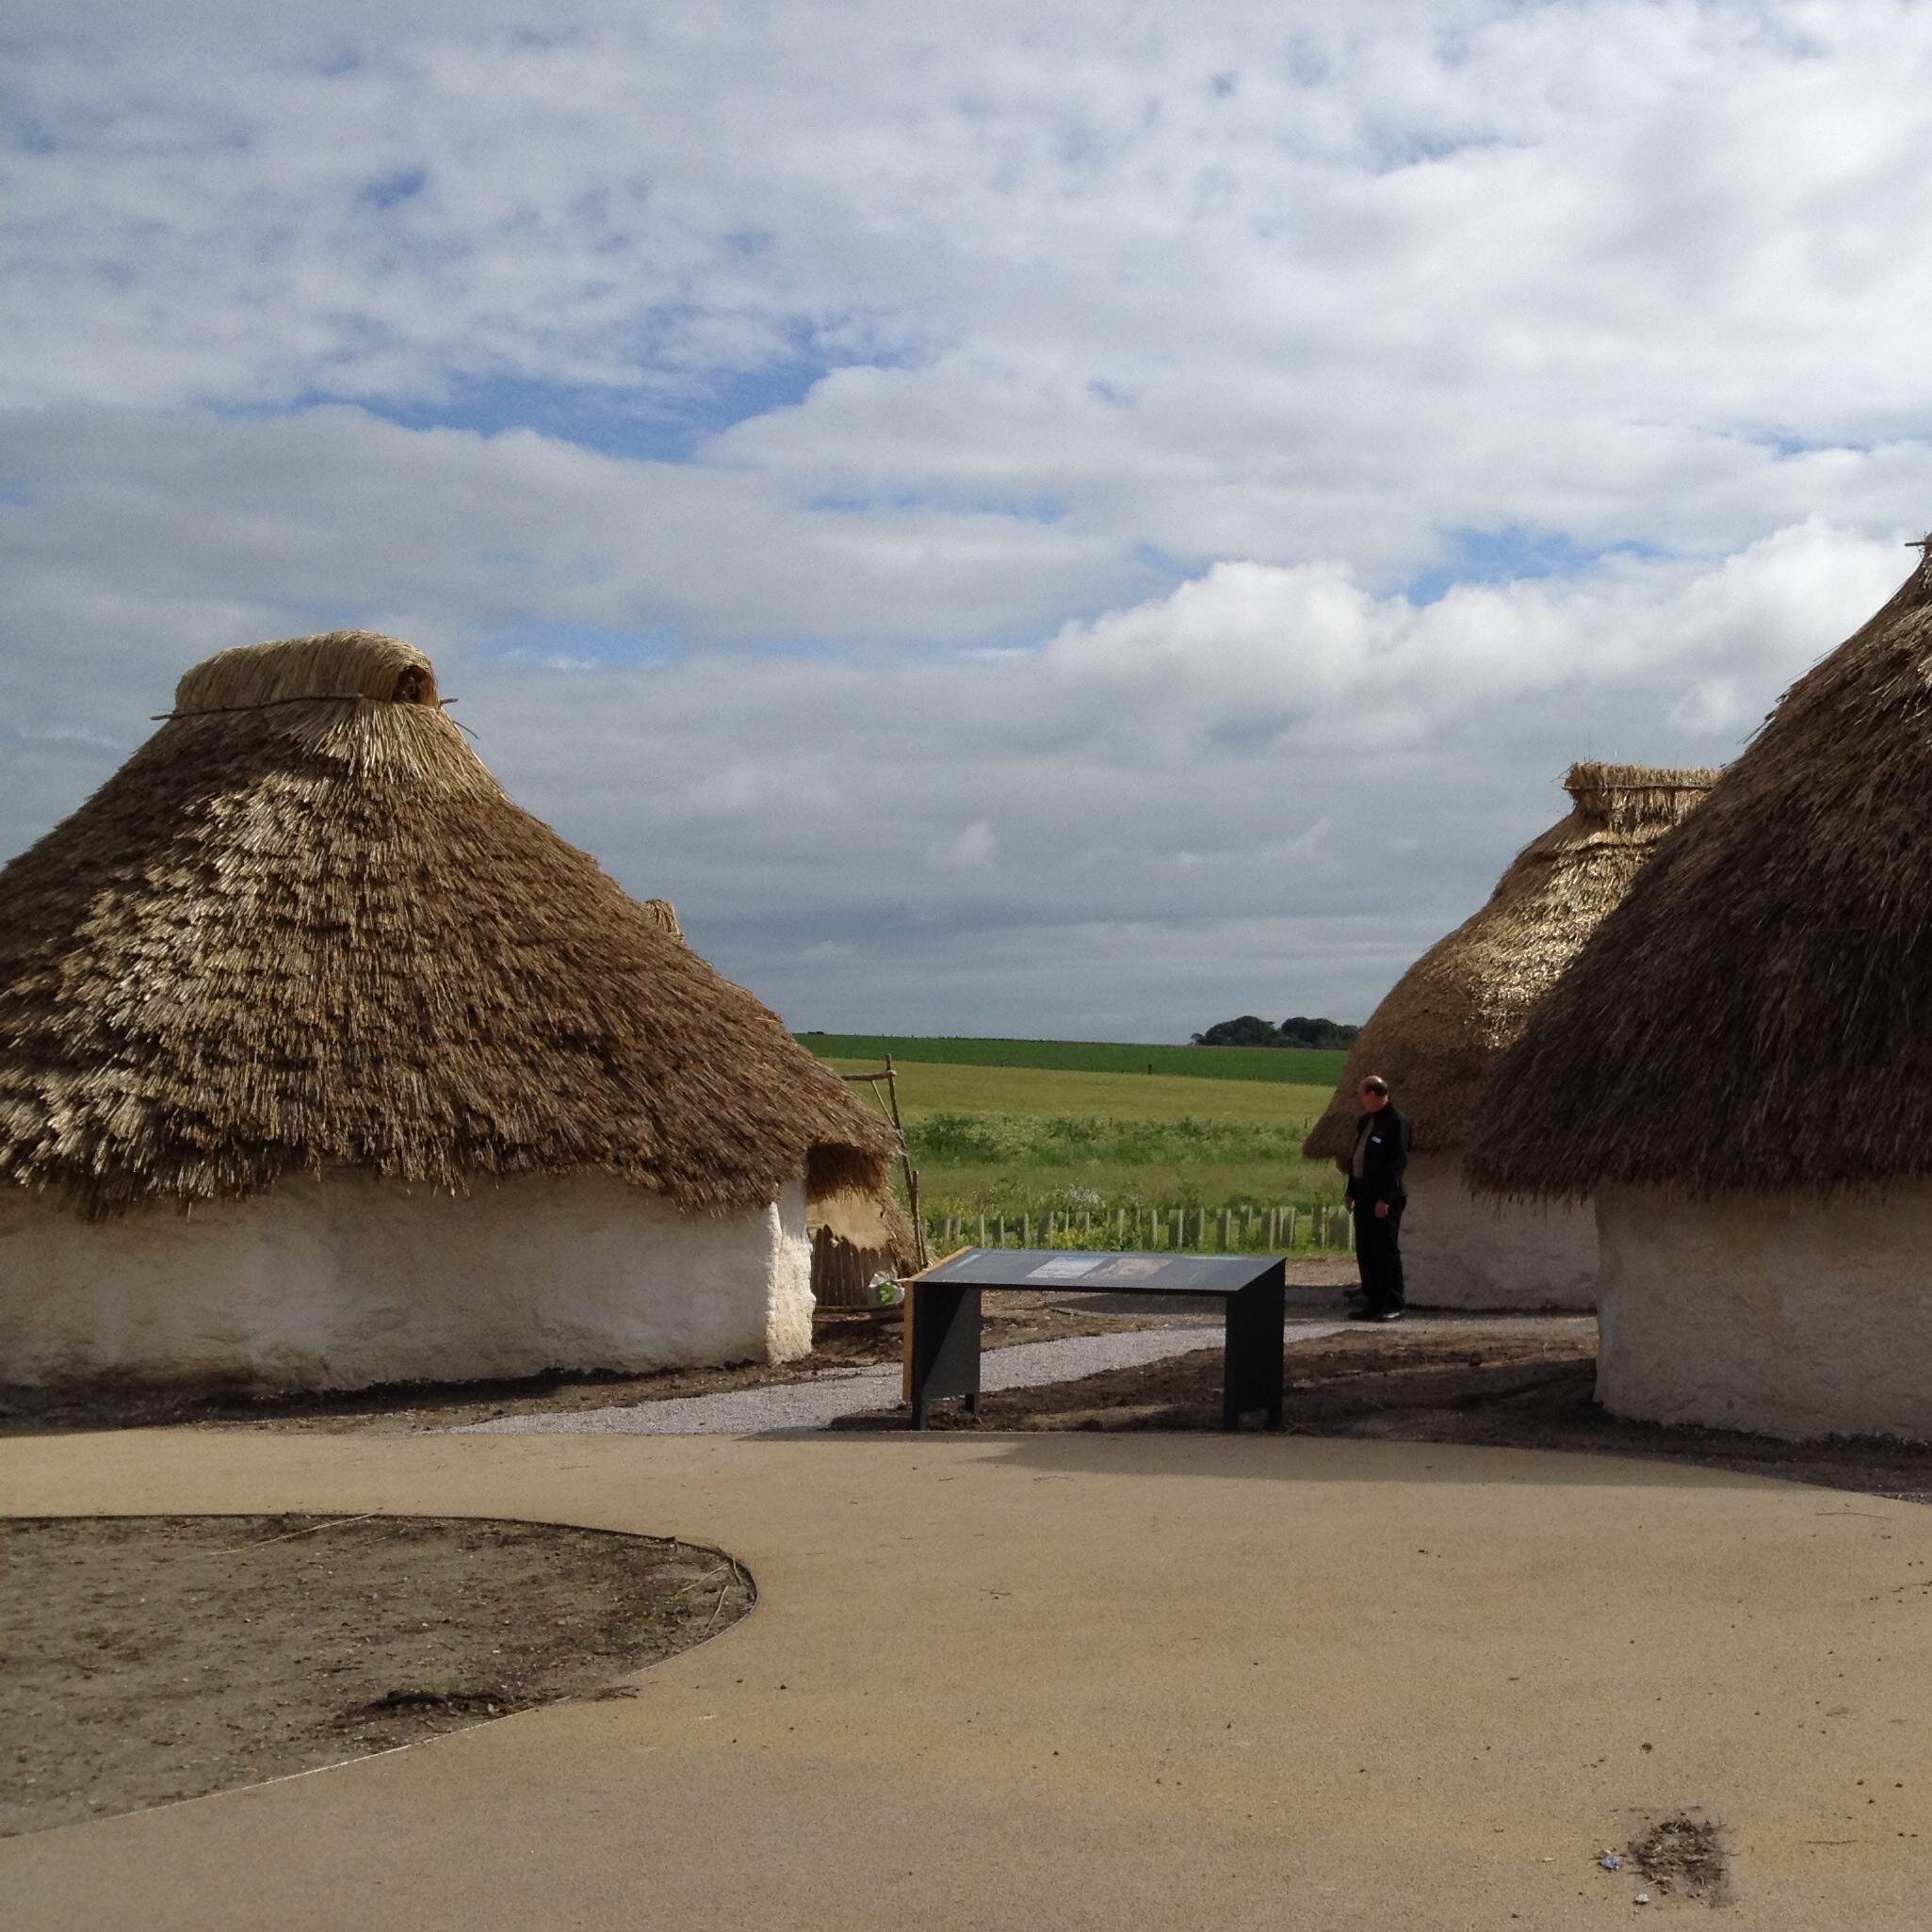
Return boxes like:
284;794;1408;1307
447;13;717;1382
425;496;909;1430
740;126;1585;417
1469;555;1932;1436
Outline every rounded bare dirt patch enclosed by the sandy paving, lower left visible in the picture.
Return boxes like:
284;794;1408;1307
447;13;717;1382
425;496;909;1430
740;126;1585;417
0;1517;754;1835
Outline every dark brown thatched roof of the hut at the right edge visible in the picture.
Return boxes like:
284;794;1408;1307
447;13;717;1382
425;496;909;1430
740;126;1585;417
1469;559;1932;1196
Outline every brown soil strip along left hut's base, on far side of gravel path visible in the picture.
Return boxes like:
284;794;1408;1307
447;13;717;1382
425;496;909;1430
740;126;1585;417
0;1292;1228;1434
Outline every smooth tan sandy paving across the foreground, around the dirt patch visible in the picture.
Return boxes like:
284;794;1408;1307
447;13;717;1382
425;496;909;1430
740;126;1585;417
0;1430;1932;1932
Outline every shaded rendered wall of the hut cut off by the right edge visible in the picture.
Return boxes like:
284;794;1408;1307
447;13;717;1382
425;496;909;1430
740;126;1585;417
1596;1182;1932;1441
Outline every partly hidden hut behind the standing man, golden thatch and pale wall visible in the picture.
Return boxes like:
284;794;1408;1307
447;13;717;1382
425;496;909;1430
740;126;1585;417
1304;763;1715;1306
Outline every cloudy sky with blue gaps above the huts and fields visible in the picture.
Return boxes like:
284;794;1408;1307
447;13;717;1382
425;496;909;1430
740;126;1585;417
0;0;1932;1039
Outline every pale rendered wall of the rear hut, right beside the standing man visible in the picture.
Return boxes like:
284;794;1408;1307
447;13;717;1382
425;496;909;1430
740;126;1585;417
1403;1153;1596;1308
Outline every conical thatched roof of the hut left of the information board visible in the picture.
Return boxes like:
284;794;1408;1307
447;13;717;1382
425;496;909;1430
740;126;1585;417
0;632;897;1213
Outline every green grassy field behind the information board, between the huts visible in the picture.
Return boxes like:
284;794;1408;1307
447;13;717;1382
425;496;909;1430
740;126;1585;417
804;1033;1342;1246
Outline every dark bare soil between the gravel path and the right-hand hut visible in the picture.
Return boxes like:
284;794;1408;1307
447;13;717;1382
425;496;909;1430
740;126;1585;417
833;1316;1932;1503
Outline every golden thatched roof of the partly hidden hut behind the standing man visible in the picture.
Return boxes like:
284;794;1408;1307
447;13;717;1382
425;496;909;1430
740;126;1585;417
1304;763;1717;1161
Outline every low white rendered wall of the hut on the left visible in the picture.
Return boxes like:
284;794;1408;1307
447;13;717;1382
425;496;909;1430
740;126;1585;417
0;1175;811;1389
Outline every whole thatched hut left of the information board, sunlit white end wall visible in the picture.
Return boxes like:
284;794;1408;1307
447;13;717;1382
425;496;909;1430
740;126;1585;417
0;632;899;1389
